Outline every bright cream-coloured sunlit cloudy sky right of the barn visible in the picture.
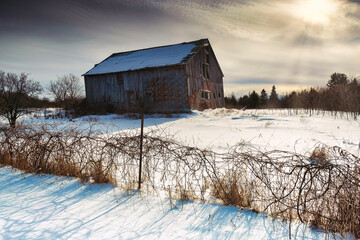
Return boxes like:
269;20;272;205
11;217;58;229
144;0;360;95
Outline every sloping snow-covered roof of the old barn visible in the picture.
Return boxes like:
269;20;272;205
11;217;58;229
84;39;209;76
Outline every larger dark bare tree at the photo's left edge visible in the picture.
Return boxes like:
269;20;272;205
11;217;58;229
0;71;42;127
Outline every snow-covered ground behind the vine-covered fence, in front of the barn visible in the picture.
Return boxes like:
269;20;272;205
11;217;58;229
23;109;360;156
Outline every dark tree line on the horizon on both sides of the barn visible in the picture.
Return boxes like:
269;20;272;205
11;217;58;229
0;71;360;127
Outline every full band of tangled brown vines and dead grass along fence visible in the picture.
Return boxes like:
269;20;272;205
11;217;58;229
0;126;360;238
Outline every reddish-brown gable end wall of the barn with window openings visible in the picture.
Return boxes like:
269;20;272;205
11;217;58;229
187;45;225;110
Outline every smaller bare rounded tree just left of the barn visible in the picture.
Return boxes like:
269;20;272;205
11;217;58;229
47;73;83;109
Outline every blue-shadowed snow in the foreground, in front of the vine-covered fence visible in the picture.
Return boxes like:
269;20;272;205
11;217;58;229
0;167;326;239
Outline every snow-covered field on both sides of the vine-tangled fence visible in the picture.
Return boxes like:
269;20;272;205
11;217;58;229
0;109;360;239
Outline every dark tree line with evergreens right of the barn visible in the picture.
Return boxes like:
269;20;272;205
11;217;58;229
225;73;360;116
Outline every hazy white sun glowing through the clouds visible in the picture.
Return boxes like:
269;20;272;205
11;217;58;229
293;0;338;24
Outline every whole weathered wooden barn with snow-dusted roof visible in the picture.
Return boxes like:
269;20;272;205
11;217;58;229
83;39;225;113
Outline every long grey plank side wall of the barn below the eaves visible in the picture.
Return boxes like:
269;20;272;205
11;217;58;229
85;66;190;113
